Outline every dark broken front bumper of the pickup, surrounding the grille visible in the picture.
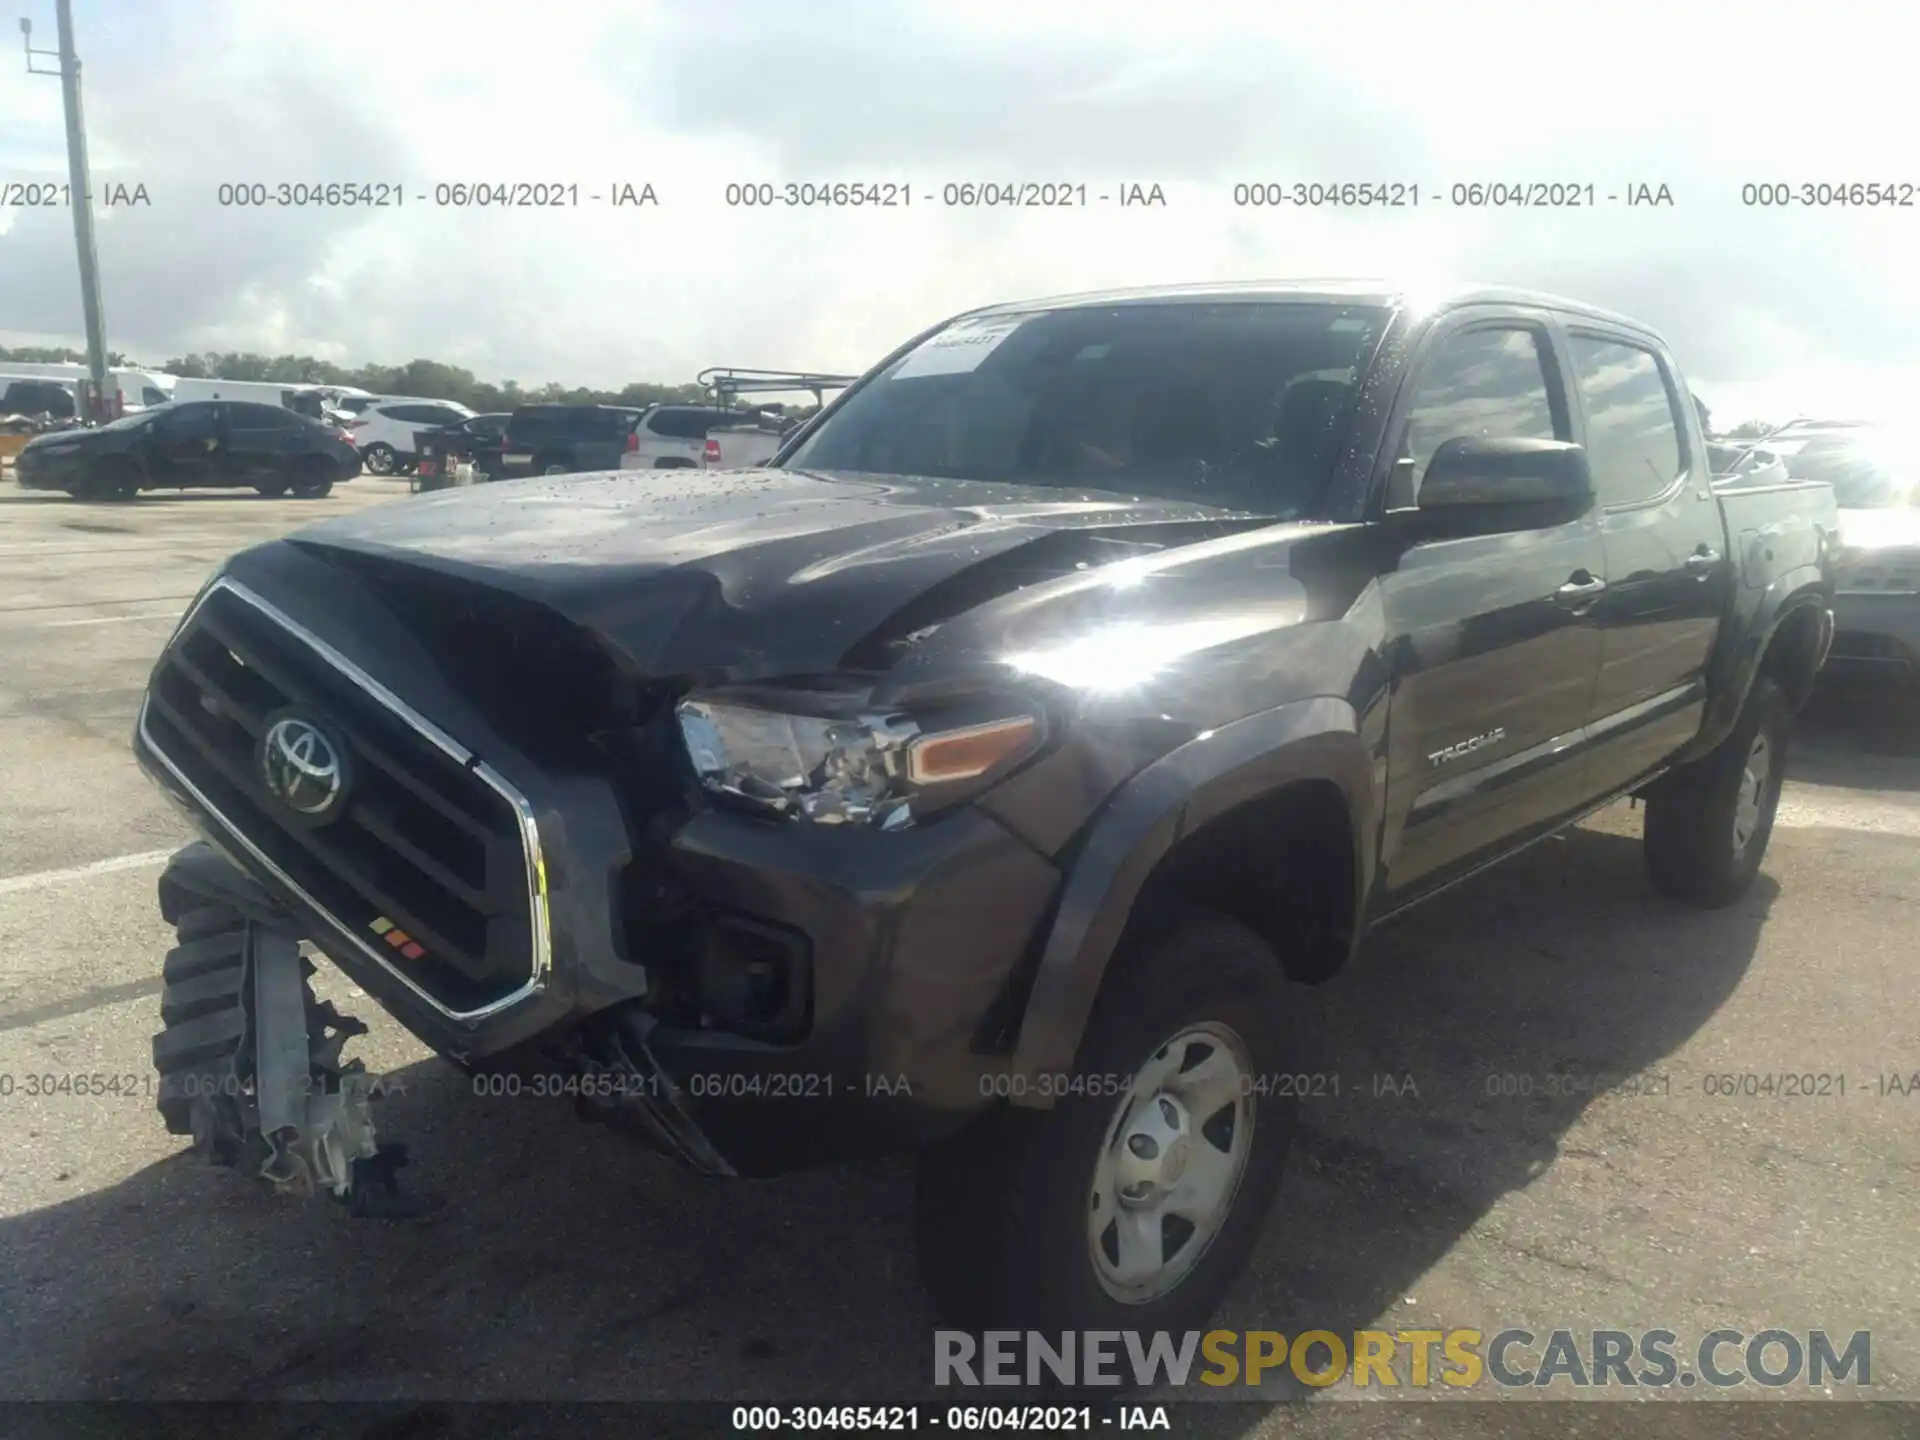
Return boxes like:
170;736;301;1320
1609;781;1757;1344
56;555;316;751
134;574;1060;1173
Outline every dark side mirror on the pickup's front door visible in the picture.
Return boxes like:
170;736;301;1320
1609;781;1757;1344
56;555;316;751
1415;436;1594;534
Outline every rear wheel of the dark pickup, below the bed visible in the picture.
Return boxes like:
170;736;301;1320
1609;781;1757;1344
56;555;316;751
1642;676;1789;908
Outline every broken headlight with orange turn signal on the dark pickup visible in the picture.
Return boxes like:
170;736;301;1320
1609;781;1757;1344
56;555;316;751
678;691;1044;829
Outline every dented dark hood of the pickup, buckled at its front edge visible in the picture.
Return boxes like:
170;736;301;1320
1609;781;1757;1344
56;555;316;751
288;470;1269;678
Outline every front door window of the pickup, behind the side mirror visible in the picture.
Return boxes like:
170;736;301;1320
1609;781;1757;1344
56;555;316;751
1390;326;1565;503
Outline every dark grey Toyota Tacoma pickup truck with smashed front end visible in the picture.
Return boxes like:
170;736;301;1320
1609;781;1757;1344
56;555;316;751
134;284;1836;1331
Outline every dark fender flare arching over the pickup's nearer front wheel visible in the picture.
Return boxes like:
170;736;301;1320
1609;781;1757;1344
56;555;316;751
1010;695;1375;1110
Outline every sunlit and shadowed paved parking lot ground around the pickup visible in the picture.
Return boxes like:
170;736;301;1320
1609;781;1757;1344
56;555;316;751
0;478;1920;1434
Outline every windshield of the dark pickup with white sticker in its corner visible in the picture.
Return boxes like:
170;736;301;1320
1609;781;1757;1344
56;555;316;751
787;301;1388;518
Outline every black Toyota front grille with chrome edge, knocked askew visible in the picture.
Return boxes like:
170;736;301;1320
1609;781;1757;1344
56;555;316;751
142;584;545;1016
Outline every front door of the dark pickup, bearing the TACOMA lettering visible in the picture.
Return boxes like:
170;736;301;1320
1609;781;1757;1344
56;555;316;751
1380;307;1605;908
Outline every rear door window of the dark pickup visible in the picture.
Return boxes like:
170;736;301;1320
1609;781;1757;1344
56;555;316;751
1572;334;1686;505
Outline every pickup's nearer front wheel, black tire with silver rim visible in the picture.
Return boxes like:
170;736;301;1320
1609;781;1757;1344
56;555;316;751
916;914;1296;1331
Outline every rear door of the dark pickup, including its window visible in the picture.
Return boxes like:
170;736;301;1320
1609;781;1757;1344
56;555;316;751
1567;330;1736;791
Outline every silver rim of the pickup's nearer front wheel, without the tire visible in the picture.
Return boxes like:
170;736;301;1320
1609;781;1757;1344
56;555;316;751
1087;1023;1254;1304
